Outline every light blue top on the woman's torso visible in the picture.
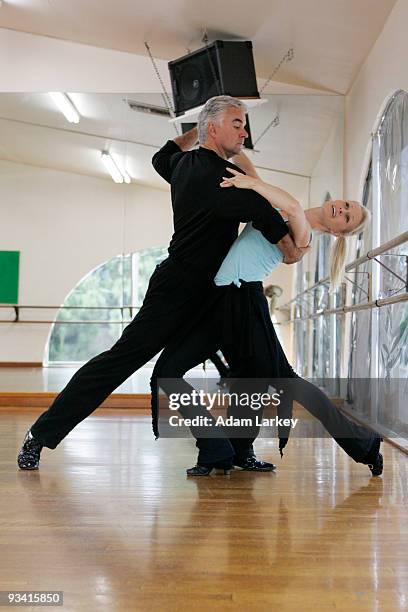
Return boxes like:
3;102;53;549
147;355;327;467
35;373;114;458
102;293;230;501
214;223;283;287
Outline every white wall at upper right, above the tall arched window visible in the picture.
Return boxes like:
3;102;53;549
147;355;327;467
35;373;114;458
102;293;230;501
344;0;408;199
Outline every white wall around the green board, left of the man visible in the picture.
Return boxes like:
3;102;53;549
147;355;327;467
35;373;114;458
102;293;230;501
0;161;172;362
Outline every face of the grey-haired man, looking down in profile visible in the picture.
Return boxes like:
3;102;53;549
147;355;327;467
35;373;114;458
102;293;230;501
210;106;248;158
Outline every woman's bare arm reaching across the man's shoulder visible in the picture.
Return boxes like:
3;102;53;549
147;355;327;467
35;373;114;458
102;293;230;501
221;168;311;248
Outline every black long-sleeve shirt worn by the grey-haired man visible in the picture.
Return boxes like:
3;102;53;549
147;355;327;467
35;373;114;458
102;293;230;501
152;140;288;280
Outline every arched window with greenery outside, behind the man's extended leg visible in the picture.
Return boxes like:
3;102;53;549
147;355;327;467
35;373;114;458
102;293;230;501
45;247;167;364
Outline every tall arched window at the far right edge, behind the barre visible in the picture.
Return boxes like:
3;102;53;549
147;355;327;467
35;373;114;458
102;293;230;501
373;91;408;437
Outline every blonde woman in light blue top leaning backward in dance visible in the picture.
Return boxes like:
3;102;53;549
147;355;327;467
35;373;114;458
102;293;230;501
152;155;383;476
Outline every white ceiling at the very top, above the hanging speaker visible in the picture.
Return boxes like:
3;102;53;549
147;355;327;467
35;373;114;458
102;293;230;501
0;0;396;94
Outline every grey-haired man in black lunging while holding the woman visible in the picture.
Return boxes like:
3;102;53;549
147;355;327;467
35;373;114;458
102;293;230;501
18;96;302;470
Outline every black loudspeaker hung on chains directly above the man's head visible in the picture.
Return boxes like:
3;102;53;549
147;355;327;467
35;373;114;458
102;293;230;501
169;40;259;116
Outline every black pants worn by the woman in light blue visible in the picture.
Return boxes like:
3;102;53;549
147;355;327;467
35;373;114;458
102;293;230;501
151;283;380;463
